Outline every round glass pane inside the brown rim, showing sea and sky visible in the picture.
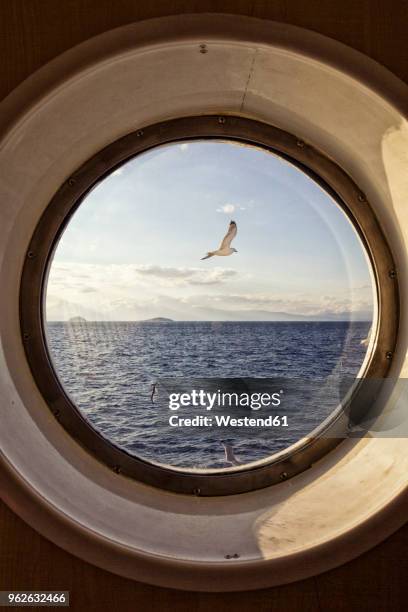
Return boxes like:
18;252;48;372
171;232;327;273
44;138;377;471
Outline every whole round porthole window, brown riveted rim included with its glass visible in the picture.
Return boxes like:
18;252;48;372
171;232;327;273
20;116;398;495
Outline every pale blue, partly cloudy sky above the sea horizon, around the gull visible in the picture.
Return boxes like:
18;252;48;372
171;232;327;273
45;140;373;321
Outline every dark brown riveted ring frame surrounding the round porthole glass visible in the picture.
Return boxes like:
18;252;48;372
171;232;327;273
20;115;399;495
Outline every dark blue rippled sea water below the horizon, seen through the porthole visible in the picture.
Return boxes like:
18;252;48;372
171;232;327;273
47;322;371;468
